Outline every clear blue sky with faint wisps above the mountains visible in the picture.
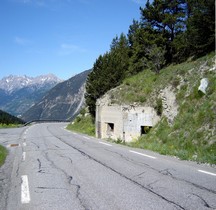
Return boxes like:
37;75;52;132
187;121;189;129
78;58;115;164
0;0;146;79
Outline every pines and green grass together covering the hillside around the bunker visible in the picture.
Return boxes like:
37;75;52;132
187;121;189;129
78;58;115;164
69;0;216;163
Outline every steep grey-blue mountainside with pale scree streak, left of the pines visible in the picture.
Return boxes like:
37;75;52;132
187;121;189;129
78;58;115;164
22;70;90;121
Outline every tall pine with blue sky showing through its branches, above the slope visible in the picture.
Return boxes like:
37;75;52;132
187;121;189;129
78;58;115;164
140;0;185;63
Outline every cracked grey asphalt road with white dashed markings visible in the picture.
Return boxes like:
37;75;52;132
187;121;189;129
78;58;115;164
0;123;216;210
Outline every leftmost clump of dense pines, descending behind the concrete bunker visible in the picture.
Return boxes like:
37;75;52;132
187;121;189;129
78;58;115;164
85;34;129;117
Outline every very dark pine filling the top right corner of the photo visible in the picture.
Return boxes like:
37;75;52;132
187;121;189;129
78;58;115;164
187;0;215;56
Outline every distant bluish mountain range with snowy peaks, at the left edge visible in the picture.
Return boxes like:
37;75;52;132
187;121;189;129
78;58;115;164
0;74;62;116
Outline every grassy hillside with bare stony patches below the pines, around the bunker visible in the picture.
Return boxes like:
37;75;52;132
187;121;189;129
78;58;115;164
103;53;216;163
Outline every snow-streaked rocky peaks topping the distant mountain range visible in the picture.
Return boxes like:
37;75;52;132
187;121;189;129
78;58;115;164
0;74;62;94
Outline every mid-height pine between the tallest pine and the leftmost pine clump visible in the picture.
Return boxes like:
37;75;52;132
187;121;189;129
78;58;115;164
128;24;165;75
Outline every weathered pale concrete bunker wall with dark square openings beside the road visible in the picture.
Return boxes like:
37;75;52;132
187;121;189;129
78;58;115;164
96;102;160;141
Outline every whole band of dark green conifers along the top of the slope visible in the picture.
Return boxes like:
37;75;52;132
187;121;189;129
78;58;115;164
85;0;215;117
